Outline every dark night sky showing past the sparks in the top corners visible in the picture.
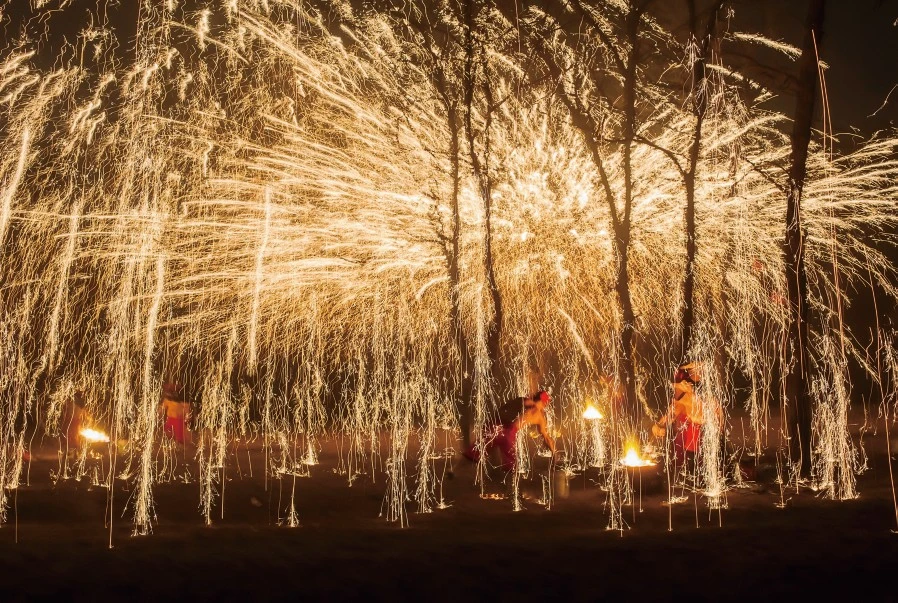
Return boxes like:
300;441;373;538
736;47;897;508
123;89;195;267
0;0;898;136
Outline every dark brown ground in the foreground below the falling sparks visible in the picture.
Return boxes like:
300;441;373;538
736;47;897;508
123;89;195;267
0;428;898;603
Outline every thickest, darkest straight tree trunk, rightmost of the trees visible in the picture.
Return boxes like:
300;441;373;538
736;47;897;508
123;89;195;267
784;0;825;477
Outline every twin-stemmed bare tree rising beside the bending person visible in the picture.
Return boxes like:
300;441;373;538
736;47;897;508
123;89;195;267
372;0;504;445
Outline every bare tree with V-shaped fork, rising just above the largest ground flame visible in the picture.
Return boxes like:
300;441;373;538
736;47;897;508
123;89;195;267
506;0;652;418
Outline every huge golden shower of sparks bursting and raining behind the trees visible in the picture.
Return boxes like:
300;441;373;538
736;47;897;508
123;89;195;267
0;0;898;533
